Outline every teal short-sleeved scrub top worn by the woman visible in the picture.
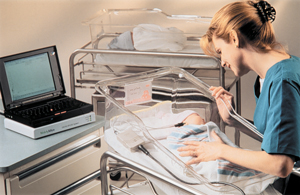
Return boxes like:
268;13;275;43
254;56;300;160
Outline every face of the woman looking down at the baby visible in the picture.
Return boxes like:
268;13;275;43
213;36;249;77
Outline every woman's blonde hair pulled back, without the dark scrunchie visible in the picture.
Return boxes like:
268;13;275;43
200;1;286;57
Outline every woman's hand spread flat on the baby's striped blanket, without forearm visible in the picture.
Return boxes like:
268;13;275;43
177;131;224;165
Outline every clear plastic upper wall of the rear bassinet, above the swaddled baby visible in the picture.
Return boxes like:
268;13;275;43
85;9;211;41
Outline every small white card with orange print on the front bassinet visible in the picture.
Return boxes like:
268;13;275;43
124;80;152;106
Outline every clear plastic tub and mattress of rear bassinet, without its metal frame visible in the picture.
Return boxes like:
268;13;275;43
79;8;219;72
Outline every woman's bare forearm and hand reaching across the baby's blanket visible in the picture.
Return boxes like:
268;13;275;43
178;132;294;177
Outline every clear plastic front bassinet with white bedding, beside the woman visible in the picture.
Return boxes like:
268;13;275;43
96;67;275;194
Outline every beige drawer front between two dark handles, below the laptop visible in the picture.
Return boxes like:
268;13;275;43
6;137;106;195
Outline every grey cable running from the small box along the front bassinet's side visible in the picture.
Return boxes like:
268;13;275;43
138;144;246;195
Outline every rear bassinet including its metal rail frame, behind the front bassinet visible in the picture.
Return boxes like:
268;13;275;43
70;9;238;100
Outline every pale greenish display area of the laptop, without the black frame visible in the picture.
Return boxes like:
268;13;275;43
4;53;55;101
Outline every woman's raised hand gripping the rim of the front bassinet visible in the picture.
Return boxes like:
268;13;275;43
209;87;235;125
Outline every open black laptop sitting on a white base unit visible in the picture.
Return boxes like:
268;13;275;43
0;46;93;138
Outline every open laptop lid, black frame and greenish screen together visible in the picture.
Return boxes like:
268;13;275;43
0;46;65;109
